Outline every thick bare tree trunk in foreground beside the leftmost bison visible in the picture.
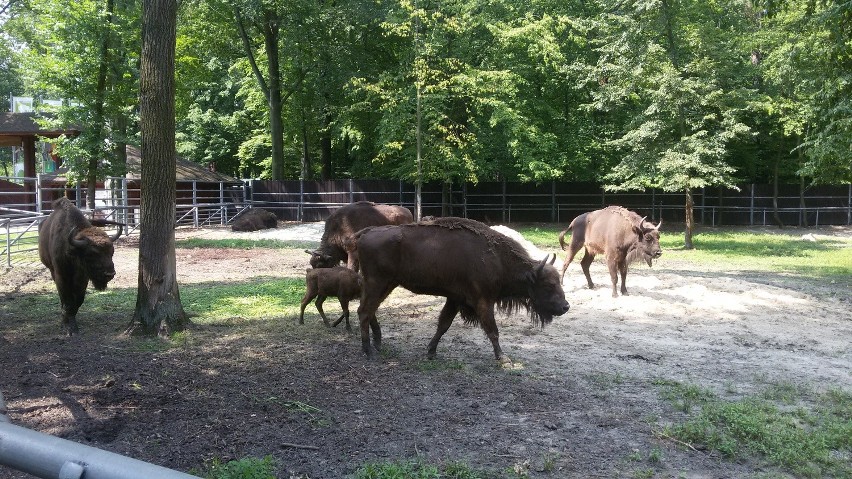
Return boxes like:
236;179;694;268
126;0;189;336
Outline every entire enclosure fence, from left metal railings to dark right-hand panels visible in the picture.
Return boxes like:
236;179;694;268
0;177;852;267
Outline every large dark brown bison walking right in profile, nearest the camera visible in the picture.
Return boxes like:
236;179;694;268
355;217;569;360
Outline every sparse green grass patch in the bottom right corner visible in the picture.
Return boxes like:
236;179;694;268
662;383;852;478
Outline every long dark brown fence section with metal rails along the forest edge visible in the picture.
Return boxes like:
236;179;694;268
246;180;852;226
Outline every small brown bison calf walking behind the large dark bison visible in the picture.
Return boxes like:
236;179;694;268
299;266;361;331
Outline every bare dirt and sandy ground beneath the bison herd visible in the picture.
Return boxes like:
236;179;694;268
0;223;852;479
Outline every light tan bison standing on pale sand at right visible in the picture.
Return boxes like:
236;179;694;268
559;206;663;298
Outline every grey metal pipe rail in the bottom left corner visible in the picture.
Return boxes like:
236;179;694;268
0;421;198;479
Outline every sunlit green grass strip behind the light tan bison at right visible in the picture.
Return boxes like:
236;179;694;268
520;224;852;280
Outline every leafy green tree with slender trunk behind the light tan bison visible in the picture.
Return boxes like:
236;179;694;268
588;0;748;249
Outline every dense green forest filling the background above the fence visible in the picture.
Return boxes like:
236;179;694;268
0;0;852;194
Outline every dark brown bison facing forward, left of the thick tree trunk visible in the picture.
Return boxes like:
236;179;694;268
38;198;123;336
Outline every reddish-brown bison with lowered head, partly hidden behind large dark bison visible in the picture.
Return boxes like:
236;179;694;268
305;201;414;268
